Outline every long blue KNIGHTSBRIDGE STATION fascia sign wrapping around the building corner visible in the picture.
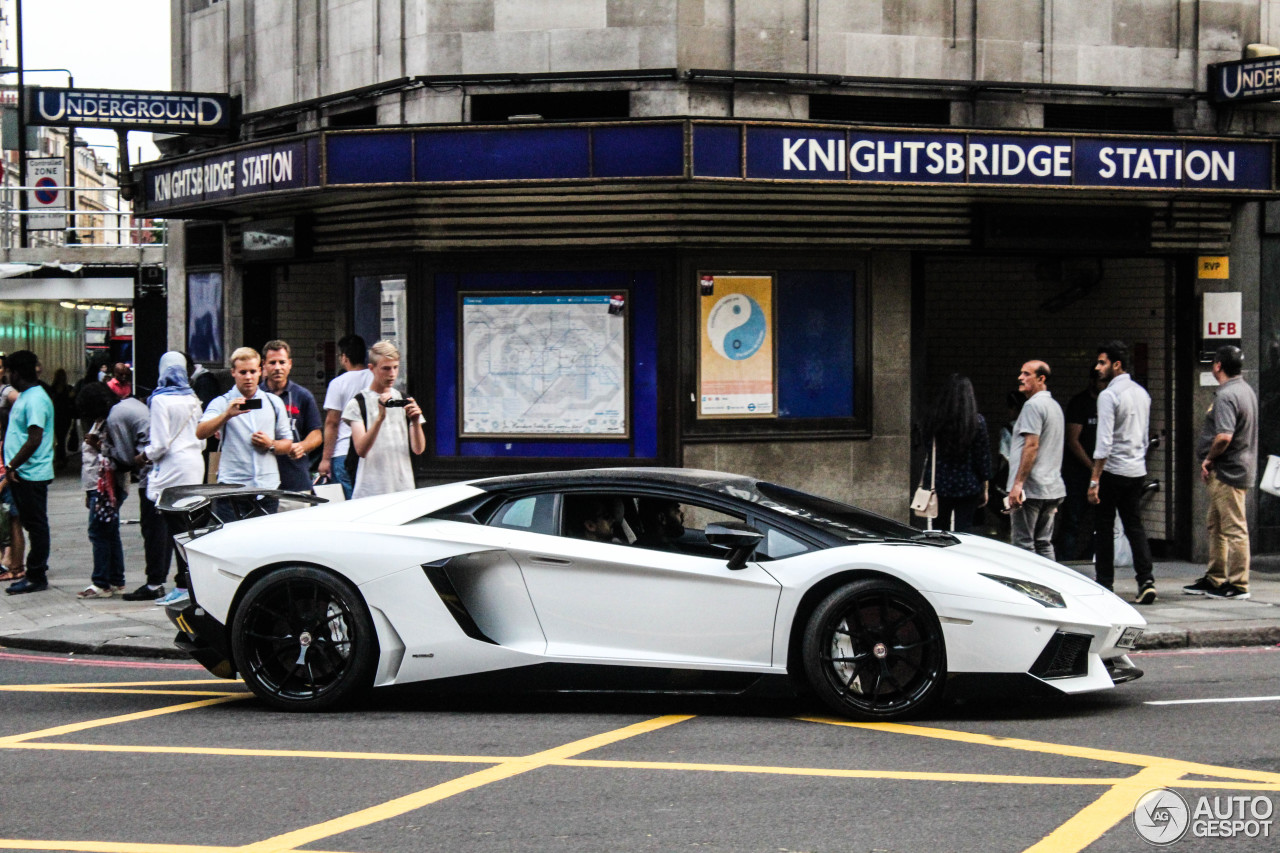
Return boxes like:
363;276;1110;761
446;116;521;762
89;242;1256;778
135;120;1274;213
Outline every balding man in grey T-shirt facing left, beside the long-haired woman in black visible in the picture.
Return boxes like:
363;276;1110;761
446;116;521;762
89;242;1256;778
1009;361;1066;560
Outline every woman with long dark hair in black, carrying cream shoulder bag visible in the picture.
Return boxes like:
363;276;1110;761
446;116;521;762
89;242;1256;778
924;373;991;533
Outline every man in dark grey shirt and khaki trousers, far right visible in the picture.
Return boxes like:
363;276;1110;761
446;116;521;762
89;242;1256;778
1183;346;1258;601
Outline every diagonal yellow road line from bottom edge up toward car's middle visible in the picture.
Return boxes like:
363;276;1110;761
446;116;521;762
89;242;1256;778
241;715;692;853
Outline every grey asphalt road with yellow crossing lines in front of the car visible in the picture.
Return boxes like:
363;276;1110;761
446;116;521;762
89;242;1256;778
0;648;1280;853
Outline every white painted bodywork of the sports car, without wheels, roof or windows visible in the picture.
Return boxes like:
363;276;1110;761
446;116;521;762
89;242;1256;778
187;473;1146;693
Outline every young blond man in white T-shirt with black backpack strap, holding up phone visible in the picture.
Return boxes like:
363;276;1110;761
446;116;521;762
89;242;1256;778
342;341;426;498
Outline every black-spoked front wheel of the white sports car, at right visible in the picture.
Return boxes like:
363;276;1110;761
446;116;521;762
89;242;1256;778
803;578;946;721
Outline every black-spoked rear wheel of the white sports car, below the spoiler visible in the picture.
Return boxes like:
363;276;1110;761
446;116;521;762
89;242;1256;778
232;566;378;711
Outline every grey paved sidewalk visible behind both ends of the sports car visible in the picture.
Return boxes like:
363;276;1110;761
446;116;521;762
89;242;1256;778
0;475;1280;660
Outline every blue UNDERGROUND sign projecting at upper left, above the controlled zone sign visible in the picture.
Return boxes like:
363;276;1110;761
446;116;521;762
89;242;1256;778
27;87;234;133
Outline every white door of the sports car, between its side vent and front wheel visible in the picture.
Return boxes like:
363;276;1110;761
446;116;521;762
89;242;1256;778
495;484;781;667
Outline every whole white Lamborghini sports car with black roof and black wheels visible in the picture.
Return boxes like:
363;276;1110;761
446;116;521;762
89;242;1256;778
161;469;1146;720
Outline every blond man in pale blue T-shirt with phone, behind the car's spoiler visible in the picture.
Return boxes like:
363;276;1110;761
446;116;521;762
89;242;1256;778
196;347;293;489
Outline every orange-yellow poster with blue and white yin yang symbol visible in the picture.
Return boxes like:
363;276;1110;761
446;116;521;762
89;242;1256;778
698;273;777;418
